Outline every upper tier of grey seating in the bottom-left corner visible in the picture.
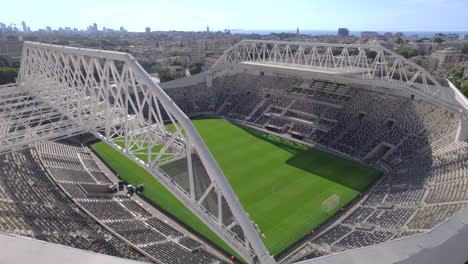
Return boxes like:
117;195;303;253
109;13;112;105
0;150;145;261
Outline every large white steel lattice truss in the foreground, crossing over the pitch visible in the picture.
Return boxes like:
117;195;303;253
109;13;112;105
0;42;275;263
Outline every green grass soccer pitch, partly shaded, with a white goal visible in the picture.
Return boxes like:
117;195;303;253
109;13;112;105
92;119;380;255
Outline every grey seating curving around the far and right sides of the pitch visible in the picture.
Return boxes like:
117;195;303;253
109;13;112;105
160;73;468;259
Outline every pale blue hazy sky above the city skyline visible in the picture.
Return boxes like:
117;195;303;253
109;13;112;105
0;0;468;31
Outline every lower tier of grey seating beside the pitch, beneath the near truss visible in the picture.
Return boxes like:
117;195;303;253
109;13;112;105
35;140;223;264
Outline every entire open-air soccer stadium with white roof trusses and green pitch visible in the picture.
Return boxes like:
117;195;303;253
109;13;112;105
0;40;468;264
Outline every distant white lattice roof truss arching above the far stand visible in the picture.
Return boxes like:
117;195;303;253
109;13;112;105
215;40;460;112
